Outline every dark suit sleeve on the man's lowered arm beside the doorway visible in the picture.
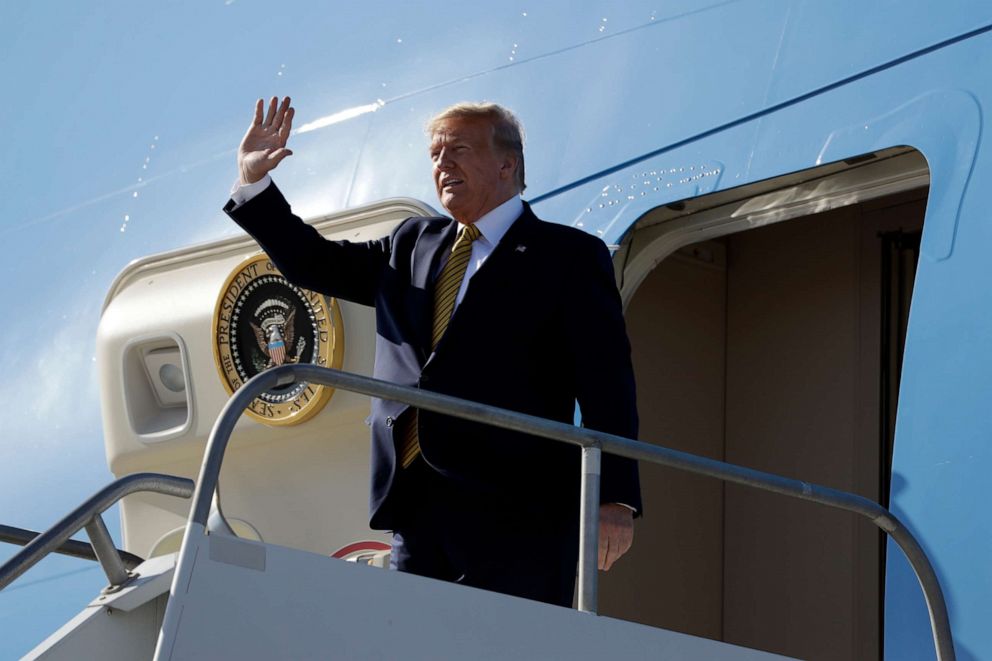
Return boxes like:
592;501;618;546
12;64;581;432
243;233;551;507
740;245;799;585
565;236;643;516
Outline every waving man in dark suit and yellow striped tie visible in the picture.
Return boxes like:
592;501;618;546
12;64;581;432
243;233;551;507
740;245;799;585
225;97;641;606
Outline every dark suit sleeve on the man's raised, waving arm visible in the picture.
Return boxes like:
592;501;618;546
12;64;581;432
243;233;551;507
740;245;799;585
224;183;390;305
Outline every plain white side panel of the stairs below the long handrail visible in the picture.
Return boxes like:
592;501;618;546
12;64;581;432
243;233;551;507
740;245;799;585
155;525;796;661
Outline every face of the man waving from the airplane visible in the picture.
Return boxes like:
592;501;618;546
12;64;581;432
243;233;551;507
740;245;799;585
430;117;517;224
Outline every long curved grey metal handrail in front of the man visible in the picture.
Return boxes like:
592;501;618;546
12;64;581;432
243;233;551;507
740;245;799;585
190;365;955;661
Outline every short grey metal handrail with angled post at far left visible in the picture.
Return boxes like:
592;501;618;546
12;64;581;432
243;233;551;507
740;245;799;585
0;473;193;592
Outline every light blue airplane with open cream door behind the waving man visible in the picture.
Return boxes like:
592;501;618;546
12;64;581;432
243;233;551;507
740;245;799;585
0;0;992;660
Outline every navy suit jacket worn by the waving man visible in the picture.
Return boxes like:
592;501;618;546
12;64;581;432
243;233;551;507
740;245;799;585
225;184;641;529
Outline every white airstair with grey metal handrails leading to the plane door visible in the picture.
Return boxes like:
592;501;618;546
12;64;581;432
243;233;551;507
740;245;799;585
0;365;954;661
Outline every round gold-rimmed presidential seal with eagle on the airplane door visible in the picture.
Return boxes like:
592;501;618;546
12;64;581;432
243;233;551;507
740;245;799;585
213;253;344;425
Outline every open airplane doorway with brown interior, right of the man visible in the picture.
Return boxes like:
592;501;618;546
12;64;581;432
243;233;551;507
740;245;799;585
601;148;929;659
